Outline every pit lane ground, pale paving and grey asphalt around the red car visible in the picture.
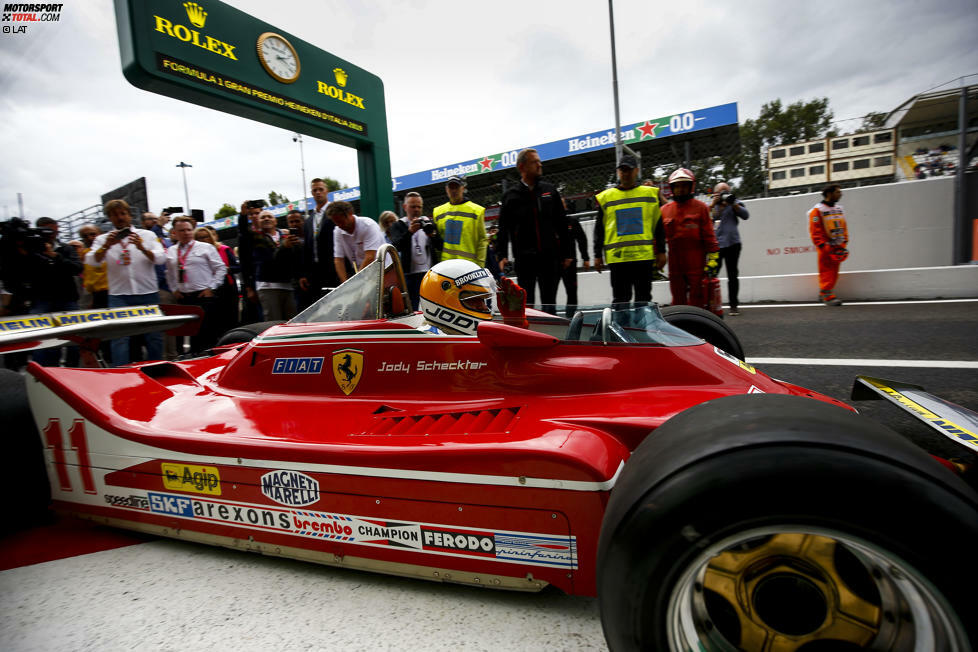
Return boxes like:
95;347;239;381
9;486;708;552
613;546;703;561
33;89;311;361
0;301;978;650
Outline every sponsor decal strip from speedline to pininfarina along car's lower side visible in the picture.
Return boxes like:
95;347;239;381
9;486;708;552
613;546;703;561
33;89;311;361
119;491;578;569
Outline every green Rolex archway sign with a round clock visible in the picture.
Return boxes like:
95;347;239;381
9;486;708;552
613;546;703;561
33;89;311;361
115;0;394;219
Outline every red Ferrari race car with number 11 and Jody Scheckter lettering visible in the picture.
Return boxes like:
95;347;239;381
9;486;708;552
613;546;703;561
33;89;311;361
5;247;978;650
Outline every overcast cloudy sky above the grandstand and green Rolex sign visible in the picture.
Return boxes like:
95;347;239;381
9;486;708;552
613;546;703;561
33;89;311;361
0;0;978;219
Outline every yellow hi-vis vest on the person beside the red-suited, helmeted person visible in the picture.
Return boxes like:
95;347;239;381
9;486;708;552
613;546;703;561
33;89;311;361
596;186;662;263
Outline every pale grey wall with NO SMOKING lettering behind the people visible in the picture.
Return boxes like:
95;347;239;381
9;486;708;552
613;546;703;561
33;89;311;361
538;177;978;305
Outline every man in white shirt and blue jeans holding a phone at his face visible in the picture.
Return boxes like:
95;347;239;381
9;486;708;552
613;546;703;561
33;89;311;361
85;199;163;367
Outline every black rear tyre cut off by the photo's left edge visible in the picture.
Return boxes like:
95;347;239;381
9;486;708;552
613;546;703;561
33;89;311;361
0;369;51;532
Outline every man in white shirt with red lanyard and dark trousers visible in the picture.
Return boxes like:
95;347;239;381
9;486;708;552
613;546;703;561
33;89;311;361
166;215;227;351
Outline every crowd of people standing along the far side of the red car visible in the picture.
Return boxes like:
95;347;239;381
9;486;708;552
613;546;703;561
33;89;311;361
0;149;784;366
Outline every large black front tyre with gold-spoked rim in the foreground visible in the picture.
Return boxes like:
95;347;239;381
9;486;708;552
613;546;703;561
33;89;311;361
597;394;978;652
